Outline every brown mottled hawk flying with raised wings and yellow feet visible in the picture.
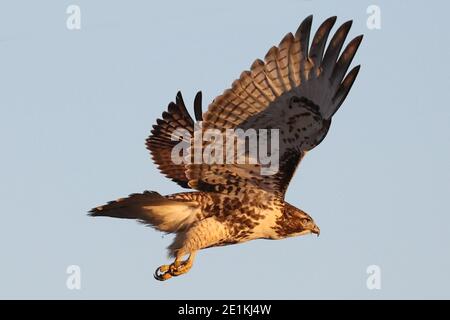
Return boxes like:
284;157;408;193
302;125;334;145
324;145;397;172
90;16;363;281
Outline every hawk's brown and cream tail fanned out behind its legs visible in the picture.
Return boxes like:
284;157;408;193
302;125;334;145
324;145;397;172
89;191;199;232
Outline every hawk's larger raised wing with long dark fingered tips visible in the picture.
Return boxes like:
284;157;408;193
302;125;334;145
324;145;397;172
186;16;362;196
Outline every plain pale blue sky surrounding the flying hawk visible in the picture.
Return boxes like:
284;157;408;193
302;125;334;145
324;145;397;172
0;0;450;299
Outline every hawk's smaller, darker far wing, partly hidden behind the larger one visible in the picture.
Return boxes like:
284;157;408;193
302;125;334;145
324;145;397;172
146;91;202;188
